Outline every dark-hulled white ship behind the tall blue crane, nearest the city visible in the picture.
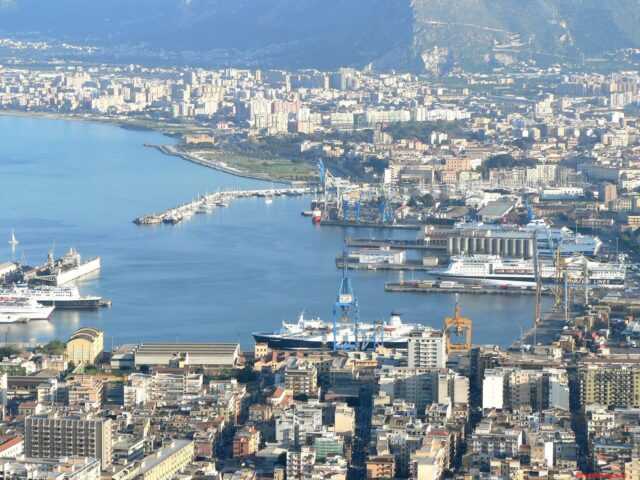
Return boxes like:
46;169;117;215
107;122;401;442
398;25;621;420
253;313;426;350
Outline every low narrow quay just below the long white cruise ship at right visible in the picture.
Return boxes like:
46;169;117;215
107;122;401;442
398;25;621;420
384;280;551;295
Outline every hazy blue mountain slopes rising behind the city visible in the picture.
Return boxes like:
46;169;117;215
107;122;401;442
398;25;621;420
0;0;640;70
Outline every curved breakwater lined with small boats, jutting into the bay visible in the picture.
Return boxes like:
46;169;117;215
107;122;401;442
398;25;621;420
133;187;311;225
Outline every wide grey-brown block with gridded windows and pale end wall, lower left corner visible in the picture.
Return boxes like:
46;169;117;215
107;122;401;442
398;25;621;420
24;415;112;468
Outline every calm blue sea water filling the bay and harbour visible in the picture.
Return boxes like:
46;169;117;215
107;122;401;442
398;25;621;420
0;117;533;347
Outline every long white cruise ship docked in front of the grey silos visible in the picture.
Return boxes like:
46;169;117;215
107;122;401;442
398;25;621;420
430;255;626;289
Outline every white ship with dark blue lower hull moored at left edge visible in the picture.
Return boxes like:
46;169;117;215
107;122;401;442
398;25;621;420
0;285;104;310
